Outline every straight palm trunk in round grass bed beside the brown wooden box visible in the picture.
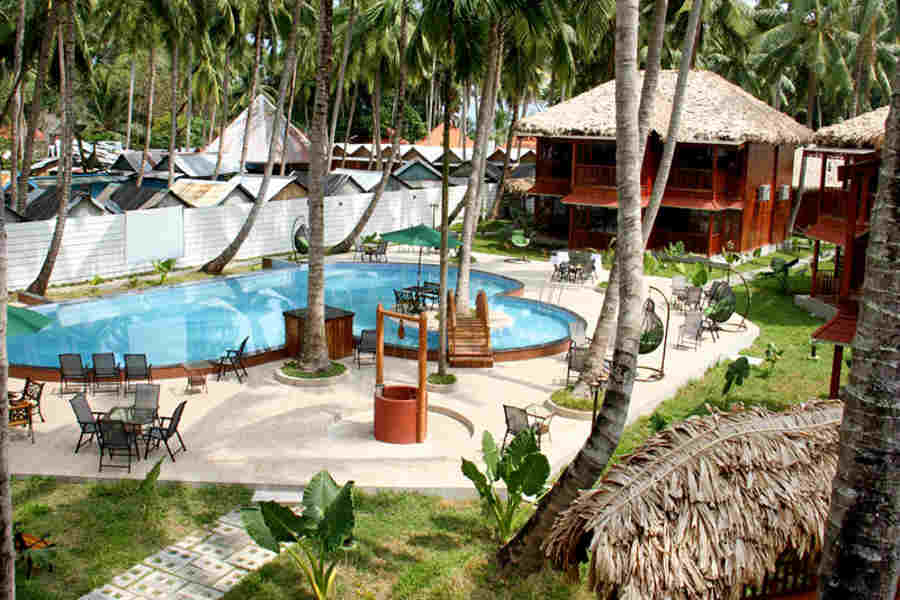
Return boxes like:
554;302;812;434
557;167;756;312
300;0;332;372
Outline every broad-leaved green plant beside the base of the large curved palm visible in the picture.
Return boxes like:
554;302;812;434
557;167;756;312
462;429;550;542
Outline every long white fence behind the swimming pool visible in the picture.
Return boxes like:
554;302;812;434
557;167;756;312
6;184;496;290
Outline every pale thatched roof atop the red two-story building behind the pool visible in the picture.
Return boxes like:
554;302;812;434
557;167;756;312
516;70;812;144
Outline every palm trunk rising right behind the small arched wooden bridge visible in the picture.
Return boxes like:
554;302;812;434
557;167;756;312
456;20;500;315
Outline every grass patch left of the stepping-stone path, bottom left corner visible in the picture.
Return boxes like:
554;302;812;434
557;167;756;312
11;476;251;600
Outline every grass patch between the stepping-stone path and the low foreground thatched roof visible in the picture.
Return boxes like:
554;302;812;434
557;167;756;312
223;492;592;600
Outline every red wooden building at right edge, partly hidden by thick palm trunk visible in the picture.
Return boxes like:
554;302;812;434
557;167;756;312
804;106;889;398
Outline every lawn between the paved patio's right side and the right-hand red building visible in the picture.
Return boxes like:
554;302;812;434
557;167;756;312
616;274;848;464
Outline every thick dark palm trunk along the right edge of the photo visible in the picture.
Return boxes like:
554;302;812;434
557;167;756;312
819;67;900;600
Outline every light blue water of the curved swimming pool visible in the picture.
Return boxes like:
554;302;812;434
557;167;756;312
7;263;578;368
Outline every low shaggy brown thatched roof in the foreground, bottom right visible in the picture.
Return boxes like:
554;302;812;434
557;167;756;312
544;402;842;600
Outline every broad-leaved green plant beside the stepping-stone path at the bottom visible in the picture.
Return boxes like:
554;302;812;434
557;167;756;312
241;471;355;600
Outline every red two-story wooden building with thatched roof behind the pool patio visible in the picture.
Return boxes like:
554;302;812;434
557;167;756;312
516;71;812;255
